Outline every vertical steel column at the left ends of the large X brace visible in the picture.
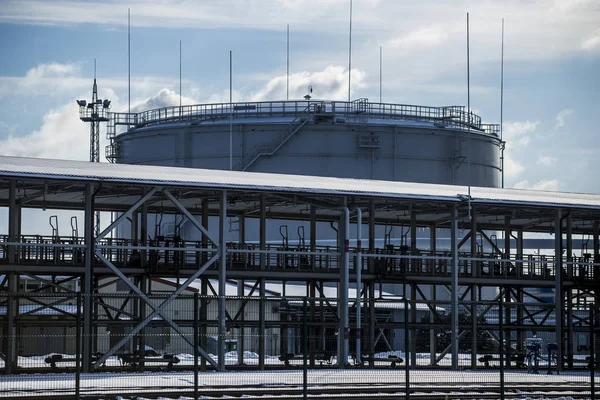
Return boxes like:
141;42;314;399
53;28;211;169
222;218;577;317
82;183;95;372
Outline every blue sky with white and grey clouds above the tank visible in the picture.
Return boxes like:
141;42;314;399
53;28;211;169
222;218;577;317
0;0;600;193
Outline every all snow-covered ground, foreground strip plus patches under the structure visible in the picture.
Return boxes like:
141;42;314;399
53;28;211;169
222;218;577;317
0;352;600;398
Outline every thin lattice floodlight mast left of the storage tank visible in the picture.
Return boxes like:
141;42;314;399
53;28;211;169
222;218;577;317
77;65;110;235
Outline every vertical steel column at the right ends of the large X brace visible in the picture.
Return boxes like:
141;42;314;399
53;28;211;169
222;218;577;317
218;190;227;371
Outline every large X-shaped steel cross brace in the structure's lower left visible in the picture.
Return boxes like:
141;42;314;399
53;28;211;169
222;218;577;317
94;252;219;368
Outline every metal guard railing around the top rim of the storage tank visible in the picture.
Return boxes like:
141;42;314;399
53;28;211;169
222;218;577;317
108;99;497;138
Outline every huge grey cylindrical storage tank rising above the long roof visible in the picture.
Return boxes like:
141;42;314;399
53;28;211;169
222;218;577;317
109;99;502;187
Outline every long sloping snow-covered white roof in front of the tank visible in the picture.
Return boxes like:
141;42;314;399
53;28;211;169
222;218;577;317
0;156;600;209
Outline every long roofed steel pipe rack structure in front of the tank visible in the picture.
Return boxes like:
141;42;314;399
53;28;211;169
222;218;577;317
0;157;600;374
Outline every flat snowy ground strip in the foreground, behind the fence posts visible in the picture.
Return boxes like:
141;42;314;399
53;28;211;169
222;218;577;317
0;369;590;398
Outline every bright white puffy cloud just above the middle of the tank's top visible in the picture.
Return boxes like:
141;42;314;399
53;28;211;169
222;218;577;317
249;65;365;101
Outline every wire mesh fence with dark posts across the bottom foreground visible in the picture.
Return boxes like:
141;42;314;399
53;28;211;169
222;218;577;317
0;292;600;399
